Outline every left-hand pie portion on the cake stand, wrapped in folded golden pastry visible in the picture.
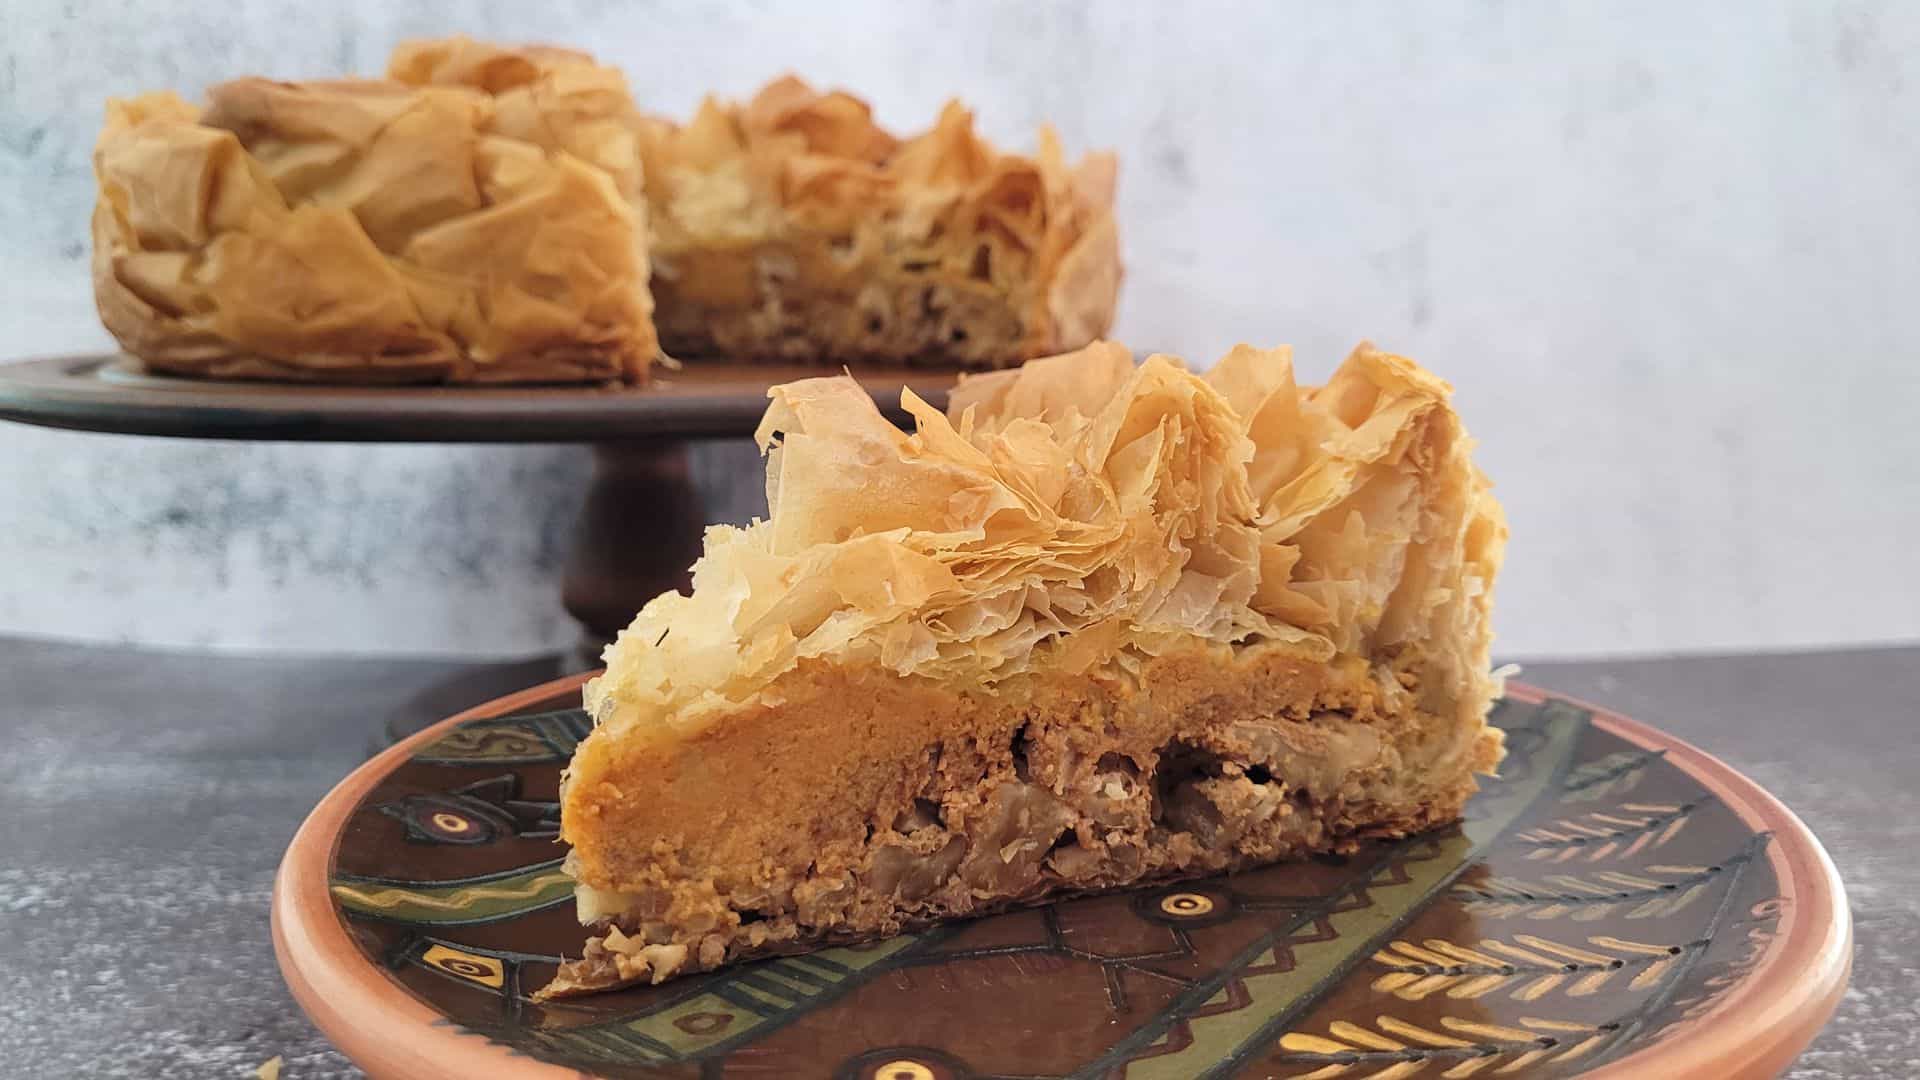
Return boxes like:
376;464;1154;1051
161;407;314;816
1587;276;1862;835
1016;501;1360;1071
92;42;659;382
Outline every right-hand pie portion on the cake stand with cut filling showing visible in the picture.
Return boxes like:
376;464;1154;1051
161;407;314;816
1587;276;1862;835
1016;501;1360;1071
639;77;1119;367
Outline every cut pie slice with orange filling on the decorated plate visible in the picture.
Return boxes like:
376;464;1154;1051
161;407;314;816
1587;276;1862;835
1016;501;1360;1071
541;342;1507;997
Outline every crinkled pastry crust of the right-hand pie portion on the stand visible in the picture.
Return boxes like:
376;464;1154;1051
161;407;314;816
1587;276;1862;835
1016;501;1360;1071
639;75;1119;356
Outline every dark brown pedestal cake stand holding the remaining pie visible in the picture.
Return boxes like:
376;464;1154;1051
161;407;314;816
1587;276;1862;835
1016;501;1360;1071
0;354;954;655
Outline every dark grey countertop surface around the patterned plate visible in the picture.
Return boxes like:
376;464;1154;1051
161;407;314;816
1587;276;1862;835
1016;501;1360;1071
0;638;1920;1080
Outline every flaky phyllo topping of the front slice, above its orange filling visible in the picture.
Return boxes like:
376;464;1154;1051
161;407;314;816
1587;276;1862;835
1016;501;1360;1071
588;342;1505;734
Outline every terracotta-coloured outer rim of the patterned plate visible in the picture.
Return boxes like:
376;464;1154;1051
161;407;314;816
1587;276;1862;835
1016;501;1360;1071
273;673;1853;1080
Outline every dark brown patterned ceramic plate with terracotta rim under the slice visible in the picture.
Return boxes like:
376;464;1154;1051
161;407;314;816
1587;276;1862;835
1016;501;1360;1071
273;676;1851;1080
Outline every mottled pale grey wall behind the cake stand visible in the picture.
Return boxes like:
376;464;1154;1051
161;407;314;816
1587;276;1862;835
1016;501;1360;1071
0;0;1920;655
